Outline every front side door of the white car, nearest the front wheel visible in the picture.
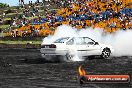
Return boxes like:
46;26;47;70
85;37;100;55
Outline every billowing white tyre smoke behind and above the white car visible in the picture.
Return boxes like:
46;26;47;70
42;25;132;56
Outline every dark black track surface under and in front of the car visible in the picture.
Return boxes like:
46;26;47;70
0;49;132;88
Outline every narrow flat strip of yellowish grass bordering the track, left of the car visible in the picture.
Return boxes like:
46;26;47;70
0;40;42;44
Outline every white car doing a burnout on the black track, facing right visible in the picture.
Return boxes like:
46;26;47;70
40;37;114;60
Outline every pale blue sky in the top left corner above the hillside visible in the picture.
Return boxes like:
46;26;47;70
0;0;42;6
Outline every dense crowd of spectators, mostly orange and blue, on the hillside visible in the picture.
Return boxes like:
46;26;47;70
4;0;132;37
